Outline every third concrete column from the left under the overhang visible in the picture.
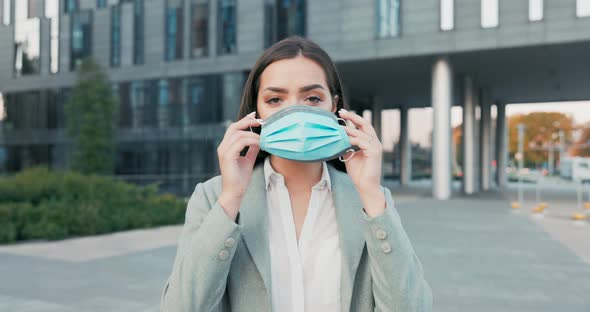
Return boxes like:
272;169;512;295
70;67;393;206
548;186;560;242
479;89;492;191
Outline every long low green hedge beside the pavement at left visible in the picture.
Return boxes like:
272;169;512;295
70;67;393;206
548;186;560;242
0;167;186;243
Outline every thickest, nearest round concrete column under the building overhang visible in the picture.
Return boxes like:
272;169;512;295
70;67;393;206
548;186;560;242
431;57;453;200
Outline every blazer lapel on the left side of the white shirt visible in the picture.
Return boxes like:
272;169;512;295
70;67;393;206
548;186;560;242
238;166;271;304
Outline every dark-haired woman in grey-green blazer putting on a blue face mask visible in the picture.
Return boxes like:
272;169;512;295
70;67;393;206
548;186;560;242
161;37;432;312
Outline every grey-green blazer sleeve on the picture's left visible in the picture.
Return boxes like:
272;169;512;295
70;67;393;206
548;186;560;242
160;182;241;312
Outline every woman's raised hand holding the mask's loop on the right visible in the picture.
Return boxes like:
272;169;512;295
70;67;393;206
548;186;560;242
339;109;385;217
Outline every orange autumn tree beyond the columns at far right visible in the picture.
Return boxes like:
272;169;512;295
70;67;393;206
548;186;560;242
508;112;574;165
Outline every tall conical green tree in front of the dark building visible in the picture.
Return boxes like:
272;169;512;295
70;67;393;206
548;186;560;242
64;58;119;175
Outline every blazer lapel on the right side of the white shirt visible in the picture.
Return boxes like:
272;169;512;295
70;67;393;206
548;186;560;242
328;166;365;311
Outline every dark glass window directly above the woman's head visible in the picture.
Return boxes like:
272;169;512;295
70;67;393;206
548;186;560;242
264;0;306;47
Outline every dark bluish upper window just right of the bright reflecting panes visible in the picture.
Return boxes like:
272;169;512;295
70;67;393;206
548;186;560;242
70;11;92;70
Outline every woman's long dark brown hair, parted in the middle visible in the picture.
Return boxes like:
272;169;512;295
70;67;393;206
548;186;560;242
238;36;348;171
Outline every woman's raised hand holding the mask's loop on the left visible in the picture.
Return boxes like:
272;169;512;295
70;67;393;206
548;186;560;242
217;112;260;221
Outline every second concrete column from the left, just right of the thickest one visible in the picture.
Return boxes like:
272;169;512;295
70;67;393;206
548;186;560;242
462;77;476;194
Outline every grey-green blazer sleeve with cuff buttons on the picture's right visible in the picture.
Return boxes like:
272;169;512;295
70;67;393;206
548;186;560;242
363;187;432;311
